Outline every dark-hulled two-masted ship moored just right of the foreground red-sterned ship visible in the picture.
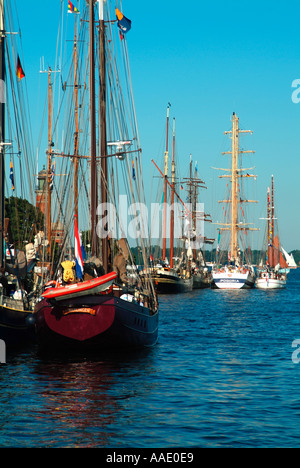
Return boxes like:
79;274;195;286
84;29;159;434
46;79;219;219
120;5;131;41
151;105;193;294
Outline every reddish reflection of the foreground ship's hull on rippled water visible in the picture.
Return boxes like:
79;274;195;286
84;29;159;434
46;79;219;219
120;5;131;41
31;353;156;447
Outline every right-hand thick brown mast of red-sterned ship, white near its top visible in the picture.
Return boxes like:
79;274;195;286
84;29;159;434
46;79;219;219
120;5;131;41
98;0;109;273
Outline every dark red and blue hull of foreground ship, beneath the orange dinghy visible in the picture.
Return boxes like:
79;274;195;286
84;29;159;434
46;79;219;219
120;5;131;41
35;275;158;349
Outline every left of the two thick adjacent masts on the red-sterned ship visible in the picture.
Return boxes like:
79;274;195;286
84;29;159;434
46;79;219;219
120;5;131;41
89;0;98;256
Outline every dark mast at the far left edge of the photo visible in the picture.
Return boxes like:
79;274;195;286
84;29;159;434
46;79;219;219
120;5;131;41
0;0;6;267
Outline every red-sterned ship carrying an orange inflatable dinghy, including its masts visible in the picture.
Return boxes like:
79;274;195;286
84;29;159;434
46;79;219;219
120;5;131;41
34;0;159;351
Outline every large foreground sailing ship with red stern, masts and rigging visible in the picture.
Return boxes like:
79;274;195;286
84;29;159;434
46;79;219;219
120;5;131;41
35;0;159;350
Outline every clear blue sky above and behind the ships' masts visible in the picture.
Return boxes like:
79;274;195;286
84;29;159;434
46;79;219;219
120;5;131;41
14;0;300;251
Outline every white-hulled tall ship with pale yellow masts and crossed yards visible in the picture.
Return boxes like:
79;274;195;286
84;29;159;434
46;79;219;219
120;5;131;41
212;113;257;289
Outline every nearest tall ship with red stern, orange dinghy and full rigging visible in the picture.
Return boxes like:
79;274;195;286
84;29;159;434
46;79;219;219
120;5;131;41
35;0;159;351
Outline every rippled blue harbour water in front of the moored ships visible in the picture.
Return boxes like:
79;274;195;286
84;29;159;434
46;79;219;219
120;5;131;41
0;271;300;448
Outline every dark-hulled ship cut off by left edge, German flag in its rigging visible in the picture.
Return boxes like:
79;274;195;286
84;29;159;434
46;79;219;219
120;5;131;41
0;0;35;347
